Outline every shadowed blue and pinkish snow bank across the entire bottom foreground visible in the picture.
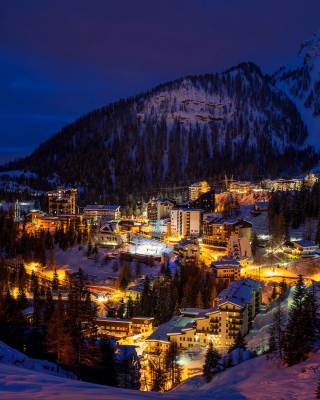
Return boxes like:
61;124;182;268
0;351;320;400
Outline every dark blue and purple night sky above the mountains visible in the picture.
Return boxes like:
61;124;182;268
0;0;320;165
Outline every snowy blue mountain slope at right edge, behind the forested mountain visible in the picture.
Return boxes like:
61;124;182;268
271;29;320;147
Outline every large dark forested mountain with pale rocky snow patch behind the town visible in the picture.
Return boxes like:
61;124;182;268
9;63;319;202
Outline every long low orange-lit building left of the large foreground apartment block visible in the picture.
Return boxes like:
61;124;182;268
96;317;154;340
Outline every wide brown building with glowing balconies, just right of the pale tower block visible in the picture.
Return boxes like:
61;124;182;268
202;217;252;246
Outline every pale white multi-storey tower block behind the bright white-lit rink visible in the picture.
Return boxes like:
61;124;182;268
170;208;203;239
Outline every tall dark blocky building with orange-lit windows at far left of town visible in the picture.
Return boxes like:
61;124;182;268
47;186;78;217
